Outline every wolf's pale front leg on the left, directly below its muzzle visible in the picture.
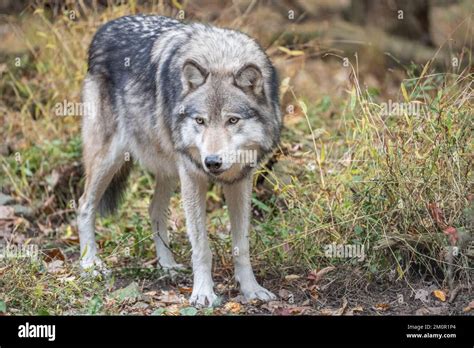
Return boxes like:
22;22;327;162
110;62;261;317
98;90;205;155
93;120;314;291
179;166;217;307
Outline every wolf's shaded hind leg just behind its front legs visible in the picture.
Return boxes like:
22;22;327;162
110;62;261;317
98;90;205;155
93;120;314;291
148;175;183;269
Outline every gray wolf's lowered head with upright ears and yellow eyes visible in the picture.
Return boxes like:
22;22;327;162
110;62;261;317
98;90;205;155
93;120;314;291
172;60;279;182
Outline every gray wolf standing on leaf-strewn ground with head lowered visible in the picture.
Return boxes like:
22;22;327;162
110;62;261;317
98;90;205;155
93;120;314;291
78;15;282;306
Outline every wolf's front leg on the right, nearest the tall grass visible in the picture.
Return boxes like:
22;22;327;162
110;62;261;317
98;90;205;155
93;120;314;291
224;175;276;301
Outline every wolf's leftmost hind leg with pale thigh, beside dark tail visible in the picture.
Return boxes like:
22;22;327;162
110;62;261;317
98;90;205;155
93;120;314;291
77;76;130;271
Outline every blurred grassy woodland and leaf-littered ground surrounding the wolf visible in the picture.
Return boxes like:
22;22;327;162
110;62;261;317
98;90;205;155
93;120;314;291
0;0;474;315
